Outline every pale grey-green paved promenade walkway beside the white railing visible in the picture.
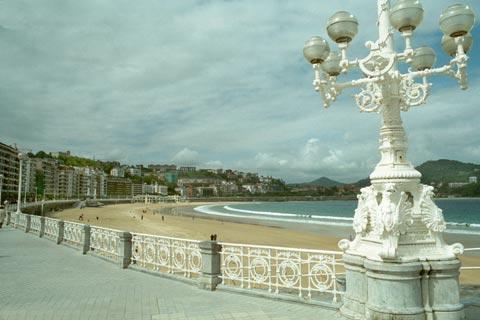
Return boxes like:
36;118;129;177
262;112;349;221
0;228;340;320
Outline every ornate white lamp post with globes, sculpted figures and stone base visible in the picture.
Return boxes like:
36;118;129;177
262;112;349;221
303;0;475;320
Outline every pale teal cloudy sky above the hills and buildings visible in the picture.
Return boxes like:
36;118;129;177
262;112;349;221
0;0;480;182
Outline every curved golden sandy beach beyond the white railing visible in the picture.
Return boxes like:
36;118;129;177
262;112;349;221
52;202;480;284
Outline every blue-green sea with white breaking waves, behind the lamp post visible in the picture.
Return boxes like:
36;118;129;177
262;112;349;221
195;198;480;235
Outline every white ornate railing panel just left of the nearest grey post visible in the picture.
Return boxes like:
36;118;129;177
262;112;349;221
132;233;202;277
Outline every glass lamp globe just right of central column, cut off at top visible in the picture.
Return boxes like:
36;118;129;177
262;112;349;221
390;0;423;32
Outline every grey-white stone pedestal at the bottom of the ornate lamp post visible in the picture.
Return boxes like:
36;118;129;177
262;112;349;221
340;254;465;320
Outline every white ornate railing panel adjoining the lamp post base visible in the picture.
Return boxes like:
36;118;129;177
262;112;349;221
221;243;344;302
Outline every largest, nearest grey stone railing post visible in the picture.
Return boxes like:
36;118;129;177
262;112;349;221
198;241;222;291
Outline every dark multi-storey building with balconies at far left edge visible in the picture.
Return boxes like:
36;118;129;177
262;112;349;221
0;142;19;201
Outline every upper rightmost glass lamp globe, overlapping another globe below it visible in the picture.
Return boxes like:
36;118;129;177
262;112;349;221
440;4;475;38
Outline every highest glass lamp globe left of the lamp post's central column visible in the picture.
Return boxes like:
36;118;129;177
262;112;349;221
327;11;358;43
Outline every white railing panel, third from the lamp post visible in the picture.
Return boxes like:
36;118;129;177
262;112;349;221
90;226;121;261
